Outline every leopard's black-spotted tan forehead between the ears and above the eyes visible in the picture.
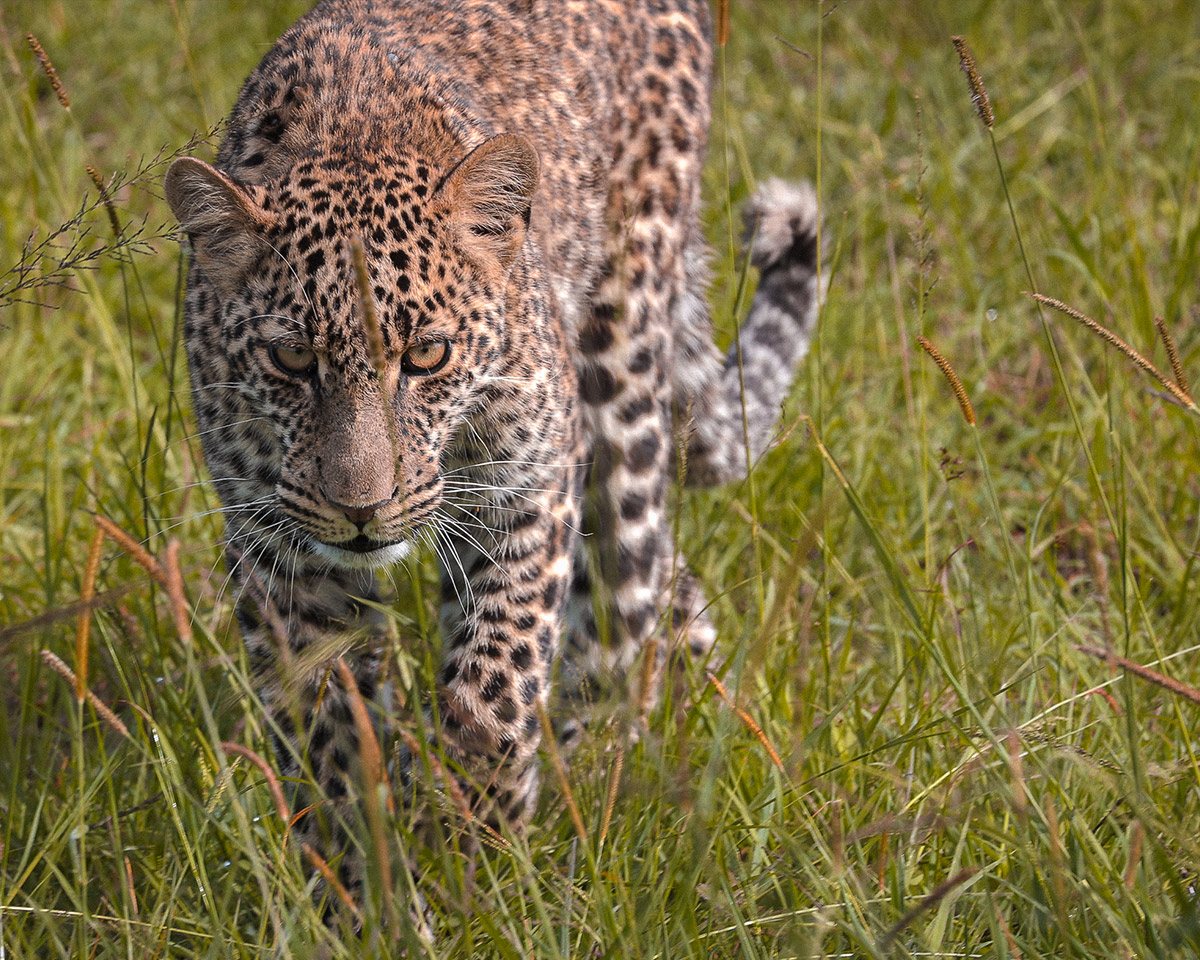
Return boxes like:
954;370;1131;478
253;155;496;364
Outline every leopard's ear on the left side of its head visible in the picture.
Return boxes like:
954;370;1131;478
163;157;274;293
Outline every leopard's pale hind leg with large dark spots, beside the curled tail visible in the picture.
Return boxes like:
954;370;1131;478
564;218;684;697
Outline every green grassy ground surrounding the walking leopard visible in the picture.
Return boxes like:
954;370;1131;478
0;0;1200;960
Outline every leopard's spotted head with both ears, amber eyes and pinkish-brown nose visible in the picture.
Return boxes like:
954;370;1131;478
167;137;538;568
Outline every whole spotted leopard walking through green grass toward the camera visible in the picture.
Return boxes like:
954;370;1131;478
164;0;823;883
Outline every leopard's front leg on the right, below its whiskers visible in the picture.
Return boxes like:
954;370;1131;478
437;469;576;826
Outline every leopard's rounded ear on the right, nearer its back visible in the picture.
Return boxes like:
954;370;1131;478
439;133;538;272
